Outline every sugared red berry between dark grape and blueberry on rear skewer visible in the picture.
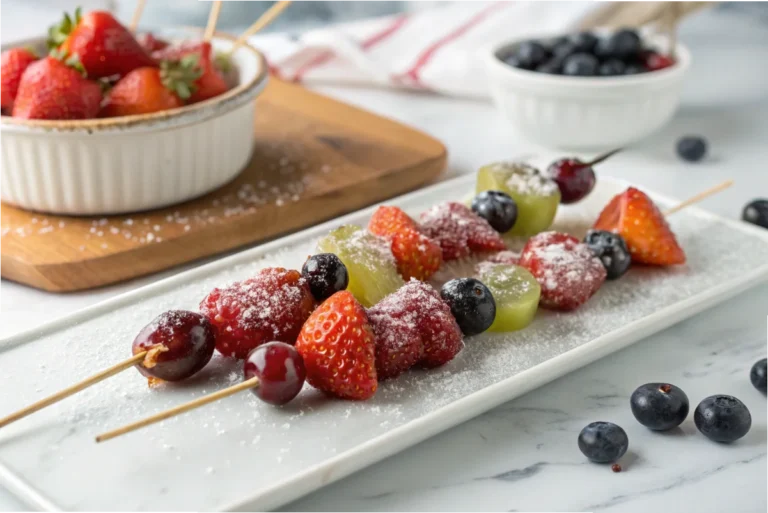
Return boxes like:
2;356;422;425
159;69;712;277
200;267;315;359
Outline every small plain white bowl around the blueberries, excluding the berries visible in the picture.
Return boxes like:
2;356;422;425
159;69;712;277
483;32;691;150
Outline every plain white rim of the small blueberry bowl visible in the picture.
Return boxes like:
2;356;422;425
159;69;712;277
485;30;691;89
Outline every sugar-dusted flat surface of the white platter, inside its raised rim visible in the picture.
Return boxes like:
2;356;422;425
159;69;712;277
0;179;768;511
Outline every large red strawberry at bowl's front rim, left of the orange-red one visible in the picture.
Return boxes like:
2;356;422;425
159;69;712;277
12;57;101;119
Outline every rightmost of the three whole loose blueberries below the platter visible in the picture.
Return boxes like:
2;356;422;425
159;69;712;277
693;395;752;442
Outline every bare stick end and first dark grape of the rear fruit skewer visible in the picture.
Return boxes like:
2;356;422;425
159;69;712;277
0;310;215;428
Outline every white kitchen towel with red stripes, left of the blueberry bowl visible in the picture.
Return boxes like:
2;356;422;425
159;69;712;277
251;0;604;98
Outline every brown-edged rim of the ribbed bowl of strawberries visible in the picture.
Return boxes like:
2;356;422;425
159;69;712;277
0;27;269;133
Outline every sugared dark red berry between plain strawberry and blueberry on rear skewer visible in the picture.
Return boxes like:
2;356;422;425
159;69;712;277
421;202;506;261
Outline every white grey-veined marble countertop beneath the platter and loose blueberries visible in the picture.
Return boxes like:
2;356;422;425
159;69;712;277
0;7;768;513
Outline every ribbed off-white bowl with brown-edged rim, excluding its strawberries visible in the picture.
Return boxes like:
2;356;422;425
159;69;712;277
0;31;268;215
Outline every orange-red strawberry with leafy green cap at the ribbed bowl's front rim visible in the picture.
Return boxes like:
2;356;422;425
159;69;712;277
101;55;200;117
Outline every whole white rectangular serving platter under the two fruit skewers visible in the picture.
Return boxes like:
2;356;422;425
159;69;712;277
0;175;768;513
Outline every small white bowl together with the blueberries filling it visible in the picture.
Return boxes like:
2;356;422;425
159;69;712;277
485;28;691;150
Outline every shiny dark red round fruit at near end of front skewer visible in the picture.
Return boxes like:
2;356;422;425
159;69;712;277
244;342;307;406
